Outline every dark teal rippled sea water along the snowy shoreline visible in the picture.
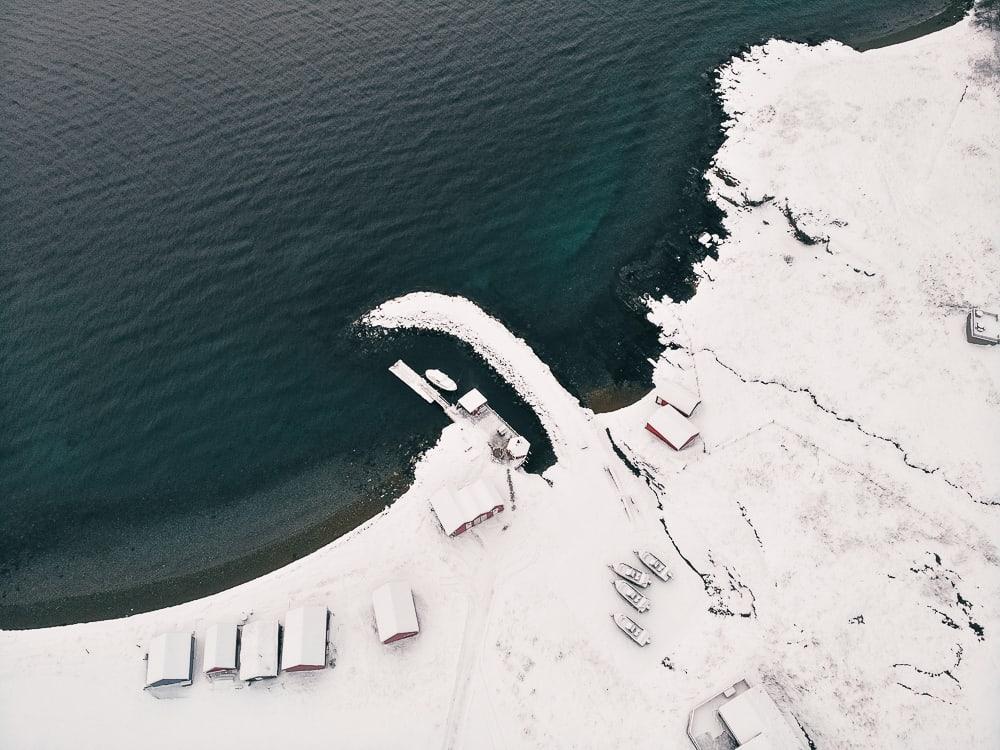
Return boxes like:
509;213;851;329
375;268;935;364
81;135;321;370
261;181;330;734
0;0;964;627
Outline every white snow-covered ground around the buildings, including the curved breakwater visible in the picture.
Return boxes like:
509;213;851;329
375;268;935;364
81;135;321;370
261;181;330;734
0;11;1000;750
